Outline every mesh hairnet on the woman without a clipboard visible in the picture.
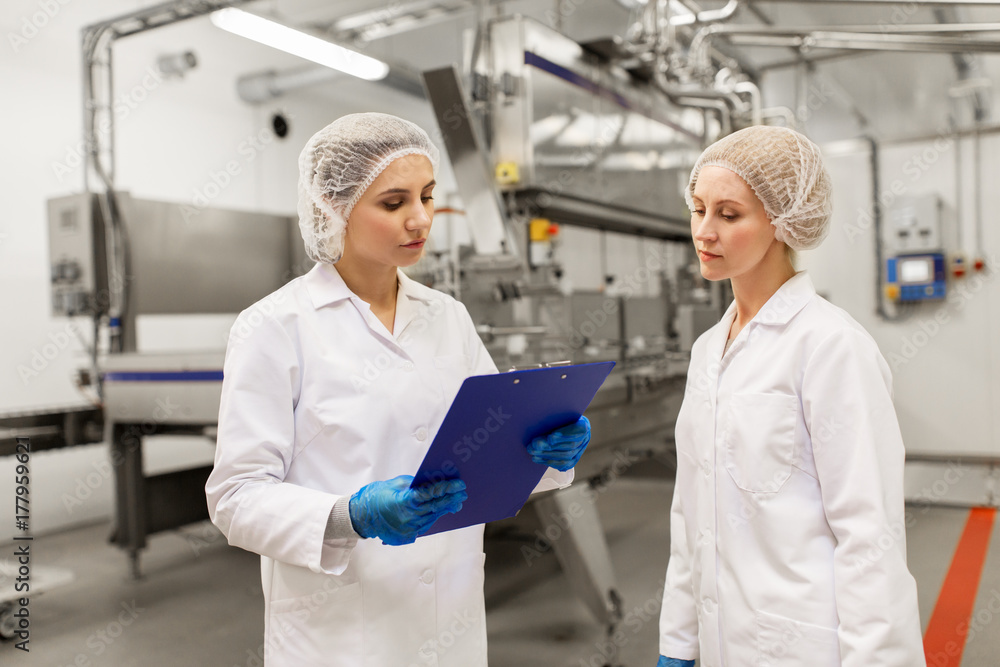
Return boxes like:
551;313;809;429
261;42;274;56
684;125;833;250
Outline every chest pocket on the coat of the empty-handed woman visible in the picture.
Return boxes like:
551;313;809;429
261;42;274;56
725;394;799;493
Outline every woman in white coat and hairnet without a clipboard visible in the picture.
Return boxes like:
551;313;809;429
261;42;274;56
658;127;925;667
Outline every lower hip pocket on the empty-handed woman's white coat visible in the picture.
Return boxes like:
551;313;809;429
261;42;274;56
754;611;840;667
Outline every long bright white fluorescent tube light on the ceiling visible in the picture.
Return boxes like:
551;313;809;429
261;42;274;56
211;7;389;81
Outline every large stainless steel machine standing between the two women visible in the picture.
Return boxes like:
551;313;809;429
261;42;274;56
416;17;718;644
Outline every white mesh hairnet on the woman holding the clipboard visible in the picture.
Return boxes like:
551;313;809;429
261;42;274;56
298;113;439;264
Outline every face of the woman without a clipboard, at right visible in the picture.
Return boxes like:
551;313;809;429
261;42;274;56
691;167;784;280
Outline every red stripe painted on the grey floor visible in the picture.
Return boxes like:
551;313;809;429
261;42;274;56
924;507;996;667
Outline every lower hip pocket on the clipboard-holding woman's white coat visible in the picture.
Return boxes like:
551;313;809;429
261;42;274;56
266;566;364;667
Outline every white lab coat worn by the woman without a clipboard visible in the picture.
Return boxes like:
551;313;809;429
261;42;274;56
660;272;926;667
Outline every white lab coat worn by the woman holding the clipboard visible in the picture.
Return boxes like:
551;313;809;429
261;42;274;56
206;264;572;667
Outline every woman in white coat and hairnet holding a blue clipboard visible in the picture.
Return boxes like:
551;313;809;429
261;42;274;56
206;113;589;667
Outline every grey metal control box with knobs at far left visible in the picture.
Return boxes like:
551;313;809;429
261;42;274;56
48;192;108;316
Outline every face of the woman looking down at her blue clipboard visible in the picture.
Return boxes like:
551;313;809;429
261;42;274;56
344;155;435;267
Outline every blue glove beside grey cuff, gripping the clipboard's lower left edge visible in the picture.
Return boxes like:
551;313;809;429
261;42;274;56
348;475;469;546
